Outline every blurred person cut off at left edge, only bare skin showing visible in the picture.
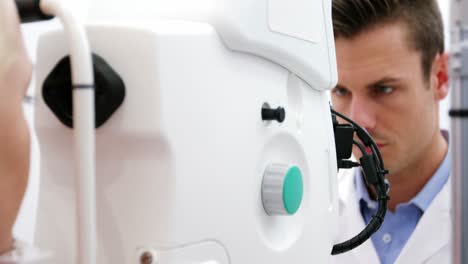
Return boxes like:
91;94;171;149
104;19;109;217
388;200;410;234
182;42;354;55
0;0;32;263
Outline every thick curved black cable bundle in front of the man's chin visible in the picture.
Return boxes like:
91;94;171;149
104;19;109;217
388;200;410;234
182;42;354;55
331;109;389;255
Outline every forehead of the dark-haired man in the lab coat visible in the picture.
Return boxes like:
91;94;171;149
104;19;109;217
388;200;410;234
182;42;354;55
335;24;421;86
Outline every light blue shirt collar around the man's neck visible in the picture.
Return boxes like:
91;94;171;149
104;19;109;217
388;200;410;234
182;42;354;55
354;130;450;212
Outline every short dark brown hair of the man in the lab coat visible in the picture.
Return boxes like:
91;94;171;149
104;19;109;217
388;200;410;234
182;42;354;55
332;0;444;79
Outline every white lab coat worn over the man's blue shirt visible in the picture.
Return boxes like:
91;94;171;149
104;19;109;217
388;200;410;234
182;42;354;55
331;169;452;264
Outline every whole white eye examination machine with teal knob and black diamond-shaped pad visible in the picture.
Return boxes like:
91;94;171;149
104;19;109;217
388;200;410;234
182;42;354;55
13;0;388;264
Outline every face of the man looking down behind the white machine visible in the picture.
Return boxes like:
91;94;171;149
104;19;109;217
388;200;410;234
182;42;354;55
332;23;446;175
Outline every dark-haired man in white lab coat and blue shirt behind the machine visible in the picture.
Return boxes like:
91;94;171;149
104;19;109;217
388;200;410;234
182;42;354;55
332;0;451;264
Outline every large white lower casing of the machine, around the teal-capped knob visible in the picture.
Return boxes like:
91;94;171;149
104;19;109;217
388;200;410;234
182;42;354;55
35;21;338;264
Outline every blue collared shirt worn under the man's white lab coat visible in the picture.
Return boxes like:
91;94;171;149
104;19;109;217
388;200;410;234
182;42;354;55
355;148;450;264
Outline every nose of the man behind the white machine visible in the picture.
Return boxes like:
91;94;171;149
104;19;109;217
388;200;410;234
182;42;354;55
349;97;376;131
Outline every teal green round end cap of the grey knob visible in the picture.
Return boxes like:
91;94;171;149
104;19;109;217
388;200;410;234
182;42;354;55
283;166;304;215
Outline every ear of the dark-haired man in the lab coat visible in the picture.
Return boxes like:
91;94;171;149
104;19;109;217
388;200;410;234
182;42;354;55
431;53;449;101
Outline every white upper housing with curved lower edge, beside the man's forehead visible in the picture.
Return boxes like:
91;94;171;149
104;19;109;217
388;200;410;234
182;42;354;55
208;0;338;90
